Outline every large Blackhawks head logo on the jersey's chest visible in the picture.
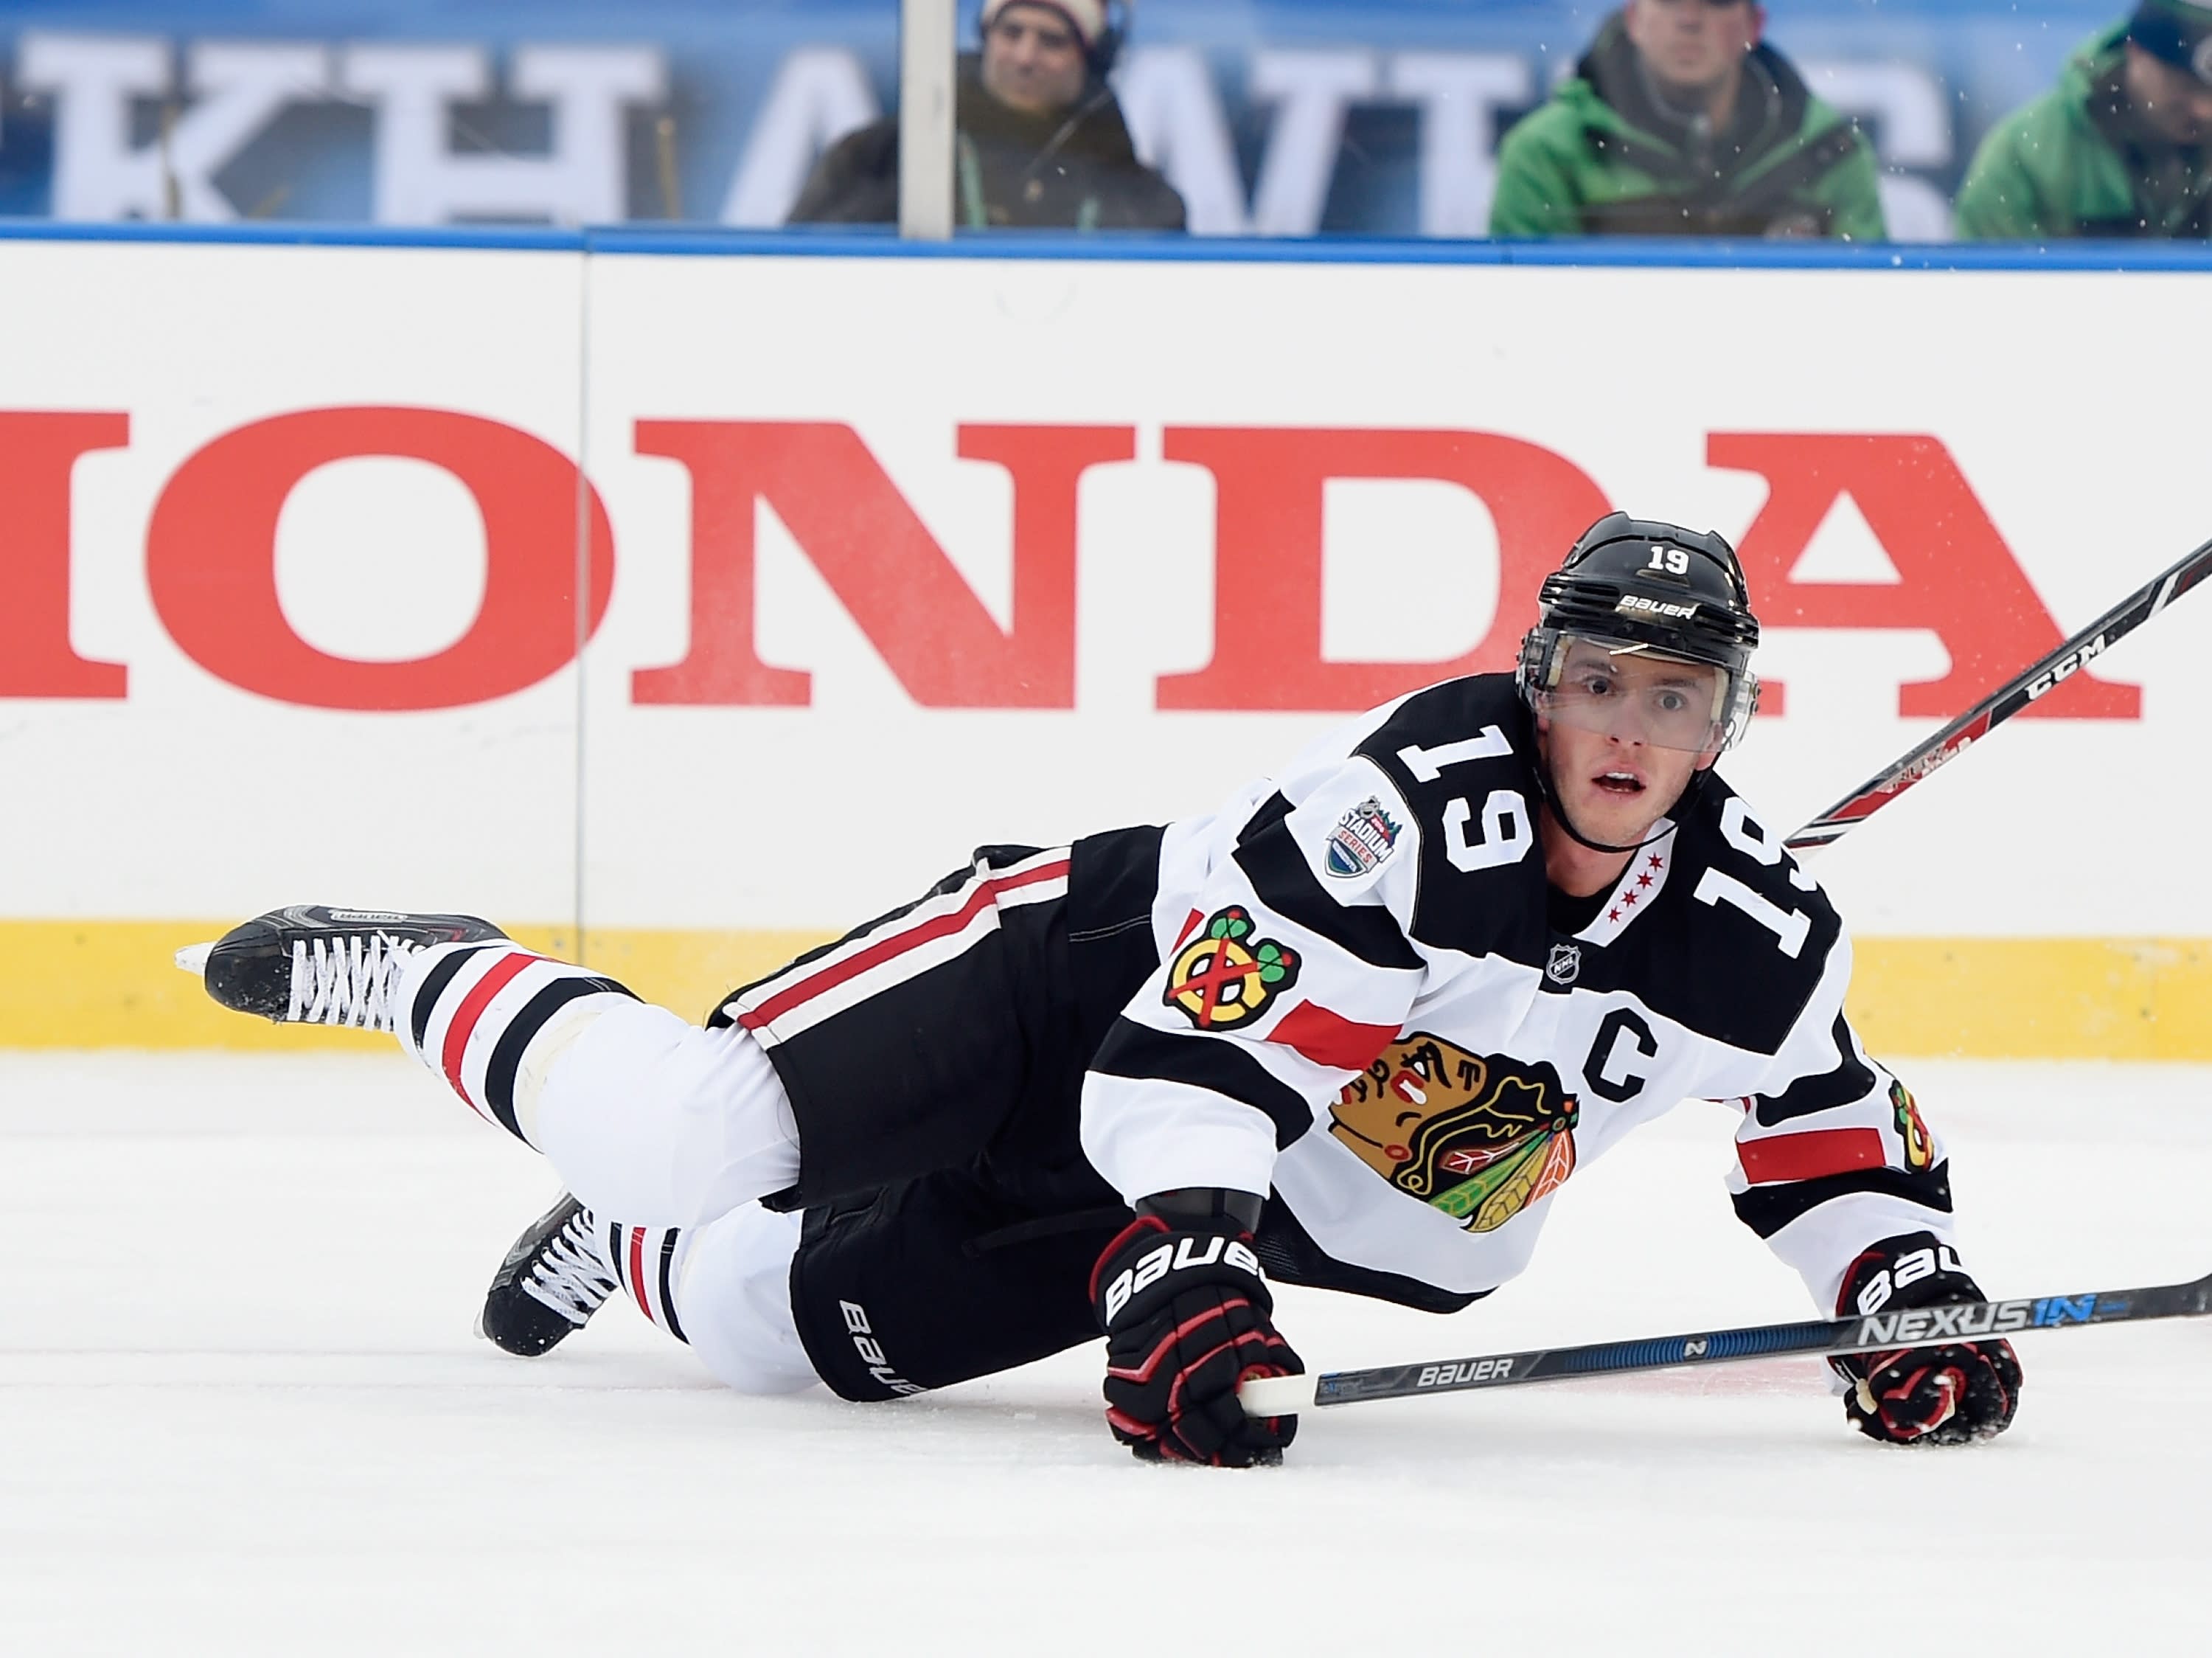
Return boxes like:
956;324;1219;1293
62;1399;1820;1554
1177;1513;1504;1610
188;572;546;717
1329;1032;1582;1233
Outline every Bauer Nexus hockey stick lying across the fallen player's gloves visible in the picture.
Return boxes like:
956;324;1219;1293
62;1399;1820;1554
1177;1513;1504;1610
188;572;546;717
1237;1273;2212;1417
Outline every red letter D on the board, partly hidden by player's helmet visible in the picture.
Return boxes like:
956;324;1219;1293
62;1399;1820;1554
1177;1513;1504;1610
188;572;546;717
1159;427;1606;710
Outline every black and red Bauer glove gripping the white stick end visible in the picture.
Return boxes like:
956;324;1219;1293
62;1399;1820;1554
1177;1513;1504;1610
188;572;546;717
1091;1191;1305;1468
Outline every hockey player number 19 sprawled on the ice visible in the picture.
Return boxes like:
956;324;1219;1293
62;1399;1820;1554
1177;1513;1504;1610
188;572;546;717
188;513;2020;1466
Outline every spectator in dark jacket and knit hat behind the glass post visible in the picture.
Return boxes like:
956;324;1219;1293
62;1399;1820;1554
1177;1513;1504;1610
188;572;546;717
792;0;1183;230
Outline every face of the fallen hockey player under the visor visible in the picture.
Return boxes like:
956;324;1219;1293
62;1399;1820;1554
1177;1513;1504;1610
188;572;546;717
1537;639;1721;846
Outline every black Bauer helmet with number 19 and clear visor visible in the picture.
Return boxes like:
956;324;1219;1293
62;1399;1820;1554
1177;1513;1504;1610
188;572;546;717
1517;511;1759;750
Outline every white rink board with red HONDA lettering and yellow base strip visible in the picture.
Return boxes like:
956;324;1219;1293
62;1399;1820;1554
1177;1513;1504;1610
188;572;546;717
0;235;2212;1058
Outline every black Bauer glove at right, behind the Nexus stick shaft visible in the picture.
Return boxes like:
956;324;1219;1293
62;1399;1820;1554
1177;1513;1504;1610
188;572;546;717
1829;1233;2020;1446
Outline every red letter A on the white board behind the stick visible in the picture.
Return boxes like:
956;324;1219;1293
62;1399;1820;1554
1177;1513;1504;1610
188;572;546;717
1705;431;2143;719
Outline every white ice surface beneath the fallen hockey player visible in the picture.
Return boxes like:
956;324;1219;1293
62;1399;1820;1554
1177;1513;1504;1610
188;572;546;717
0;1054;2212;1658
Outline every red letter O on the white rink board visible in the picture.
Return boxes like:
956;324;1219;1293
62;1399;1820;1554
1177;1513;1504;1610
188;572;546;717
146;407;615;710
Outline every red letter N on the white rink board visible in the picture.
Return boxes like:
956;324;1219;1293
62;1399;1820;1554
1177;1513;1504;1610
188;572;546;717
630;420;1137;708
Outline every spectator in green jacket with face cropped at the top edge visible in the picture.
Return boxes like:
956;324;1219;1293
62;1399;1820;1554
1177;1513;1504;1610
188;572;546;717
1491;0;1882;241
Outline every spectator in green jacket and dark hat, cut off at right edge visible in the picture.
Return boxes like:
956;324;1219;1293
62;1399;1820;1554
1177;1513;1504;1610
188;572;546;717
1955;0;2212;241
